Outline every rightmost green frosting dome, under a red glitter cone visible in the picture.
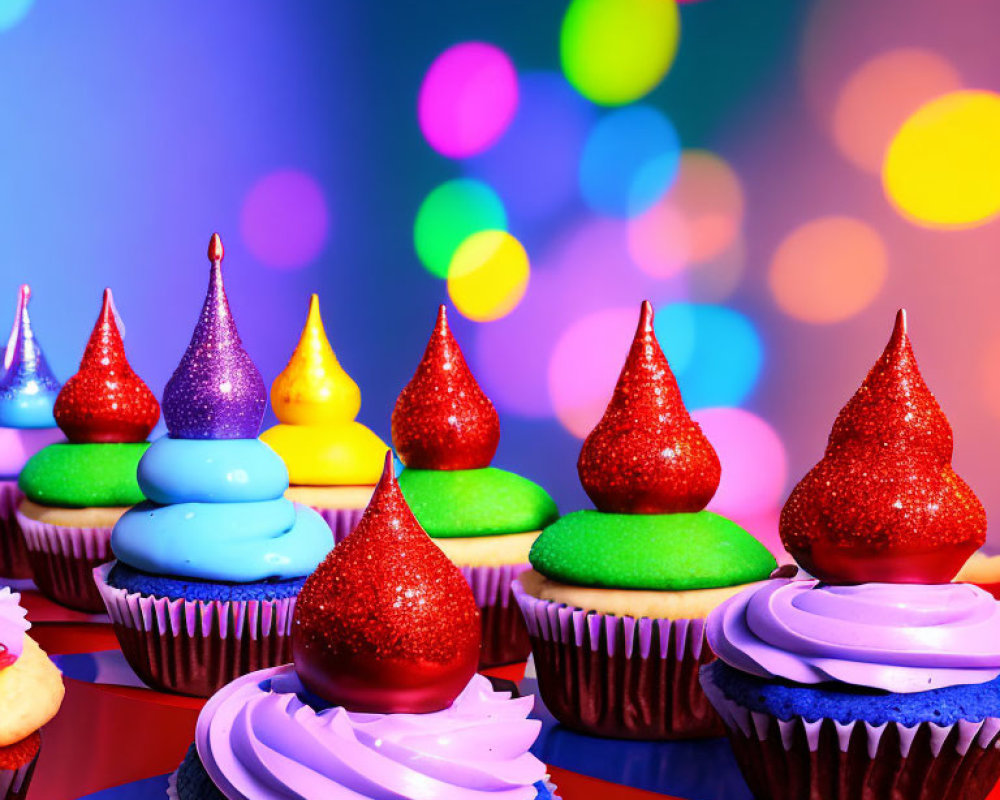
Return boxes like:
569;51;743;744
531;511;777;591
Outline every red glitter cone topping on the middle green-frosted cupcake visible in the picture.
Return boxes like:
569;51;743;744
392;306;500;469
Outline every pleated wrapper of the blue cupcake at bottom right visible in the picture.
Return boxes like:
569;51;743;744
702;672;1000;800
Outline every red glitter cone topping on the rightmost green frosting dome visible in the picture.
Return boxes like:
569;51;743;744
576;300;722;514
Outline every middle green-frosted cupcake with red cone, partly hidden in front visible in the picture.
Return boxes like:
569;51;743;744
392;306;559;666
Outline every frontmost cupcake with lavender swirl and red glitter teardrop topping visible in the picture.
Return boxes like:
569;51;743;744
168;455;552;800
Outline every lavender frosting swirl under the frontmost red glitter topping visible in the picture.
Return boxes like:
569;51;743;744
195;665;545;800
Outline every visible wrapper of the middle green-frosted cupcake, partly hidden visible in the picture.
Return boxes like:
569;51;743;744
459;564;531;667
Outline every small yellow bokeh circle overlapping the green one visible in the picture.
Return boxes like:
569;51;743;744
448;231;530;322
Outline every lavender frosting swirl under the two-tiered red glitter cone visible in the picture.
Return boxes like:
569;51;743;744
707;580;1000;693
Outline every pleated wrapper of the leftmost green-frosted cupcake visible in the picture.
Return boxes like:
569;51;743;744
17;512;114;613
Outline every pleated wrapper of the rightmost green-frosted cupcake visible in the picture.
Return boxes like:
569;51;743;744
514;582;724;739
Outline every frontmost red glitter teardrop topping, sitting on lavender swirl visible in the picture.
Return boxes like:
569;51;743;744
292;452;480;714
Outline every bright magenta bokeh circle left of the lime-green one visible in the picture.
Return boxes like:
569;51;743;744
417;42;518;158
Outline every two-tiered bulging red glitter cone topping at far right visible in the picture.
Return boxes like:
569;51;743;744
780;311;986;583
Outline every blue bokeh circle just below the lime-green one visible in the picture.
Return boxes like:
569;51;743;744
580;106;680;217
